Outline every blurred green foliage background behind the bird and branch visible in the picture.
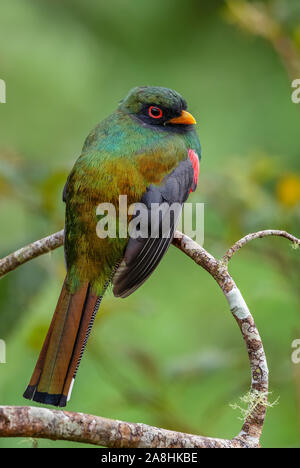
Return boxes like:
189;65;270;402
0;0;300;447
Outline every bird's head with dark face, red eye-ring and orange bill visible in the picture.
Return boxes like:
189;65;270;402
119;86;196;131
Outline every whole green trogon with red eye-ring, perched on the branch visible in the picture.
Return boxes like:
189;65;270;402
24;86;201;406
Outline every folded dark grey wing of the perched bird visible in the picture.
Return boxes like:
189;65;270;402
112;159;196;297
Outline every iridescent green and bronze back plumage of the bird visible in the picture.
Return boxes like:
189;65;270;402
65;108;198;293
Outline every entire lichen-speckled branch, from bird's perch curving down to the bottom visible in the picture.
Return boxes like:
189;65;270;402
0;230;300;448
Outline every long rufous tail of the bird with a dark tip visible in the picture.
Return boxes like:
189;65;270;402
23;280;107;406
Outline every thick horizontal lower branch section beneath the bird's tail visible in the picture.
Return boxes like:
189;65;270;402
0;406;245;448
